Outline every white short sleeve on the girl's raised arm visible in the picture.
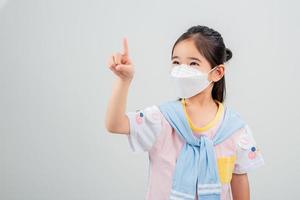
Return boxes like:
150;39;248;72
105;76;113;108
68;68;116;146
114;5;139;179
126;105;163;152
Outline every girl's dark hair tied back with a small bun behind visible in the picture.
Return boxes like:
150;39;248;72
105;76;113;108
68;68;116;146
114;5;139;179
171;25;232;102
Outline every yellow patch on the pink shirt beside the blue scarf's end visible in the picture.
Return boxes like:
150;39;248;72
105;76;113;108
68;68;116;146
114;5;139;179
217;156;236;184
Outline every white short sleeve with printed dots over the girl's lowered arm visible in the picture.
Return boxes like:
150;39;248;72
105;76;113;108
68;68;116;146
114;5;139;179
233;125;264;174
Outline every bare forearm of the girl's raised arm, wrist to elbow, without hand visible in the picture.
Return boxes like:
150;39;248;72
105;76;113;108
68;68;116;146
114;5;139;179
106;78;131;134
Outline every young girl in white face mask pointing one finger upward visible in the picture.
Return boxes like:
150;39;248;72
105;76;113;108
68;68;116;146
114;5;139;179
106;26;264;200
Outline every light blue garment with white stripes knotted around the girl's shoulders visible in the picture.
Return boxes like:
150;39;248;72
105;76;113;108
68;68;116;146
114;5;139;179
159;101;245;200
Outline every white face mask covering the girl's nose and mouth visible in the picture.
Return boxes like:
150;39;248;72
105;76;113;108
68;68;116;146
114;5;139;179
170;64;217;98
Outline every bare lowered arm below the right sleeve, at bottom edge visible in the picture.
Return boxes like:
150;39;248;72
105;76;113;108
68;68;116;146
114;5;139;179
231;174;250;200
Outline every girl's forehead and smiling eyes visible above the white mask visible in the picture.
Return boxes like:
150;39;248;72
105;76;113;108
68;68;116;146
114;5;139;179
172;39;211;73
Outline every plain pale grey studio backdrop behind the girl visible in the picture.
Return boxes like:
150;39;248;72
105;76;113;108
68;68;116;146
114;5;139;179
0;0;300;200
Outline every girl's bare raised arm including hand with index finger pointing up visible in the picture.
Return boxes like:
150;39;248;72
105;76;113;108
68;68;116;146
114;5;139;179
105;38;134;134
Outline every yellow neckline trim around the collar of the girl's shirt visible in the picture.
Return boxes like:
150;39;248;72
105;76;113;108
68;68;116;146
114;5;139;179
181;99;224;132
